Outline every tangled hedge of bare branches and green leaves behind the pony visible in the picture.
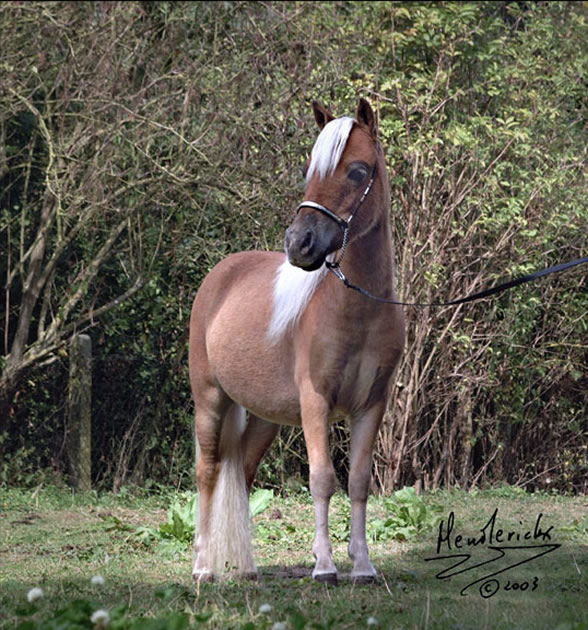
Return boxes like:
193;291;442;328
0;1;588;492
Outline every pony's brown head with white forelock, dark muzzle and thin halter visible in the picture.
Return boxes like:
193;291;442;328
285;99;378;271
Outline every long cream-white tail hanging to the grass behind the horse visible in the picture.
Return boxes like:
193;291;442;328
196;404;257;577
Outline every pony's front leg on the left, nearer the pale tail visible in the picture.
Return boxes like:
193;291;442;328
301;391;337;584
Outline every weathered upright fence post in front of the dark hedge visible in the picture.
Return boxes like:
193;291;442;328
68;335;92;490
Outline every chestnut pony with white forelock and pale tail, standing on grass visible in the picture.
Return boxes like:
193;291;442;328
189;98;404;584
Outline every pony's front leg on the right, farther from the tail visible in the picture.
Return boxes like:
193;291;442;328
349;405;384;582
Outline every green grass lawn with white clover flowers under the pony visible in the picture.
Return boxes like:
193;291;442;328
0;488;588;630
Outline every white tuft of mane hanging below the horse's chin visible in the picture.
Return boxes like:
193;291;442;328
268;260;327;341
